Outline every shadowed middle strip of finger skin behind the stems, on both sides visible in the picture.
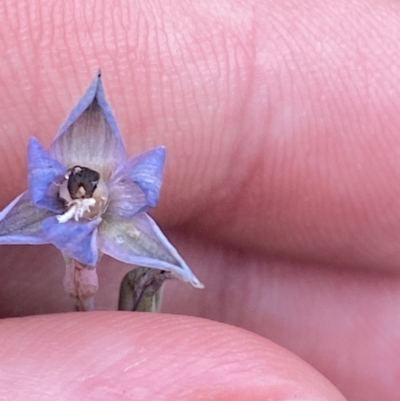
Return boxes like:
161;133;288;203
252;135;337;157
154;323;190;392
0;236;400;401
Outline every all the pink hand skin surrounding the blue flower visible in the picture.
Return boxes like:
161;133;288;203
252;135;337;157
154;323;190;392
0;0;400;401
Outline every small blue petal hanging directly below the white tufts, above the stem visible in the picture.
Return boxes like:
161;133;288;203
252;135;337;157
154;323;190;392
42;216;101;266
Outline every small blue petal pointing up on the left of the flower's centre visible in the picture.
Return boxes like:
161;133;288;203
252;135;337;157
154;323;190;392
28;138;67;213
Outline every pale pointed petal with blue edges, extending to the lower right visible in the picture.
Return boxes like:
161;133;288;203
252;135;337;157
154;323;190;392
99;213;203;288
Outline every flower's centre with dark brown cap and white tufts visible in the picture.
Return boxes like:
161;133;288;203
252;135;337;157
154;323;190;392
57;166;108;223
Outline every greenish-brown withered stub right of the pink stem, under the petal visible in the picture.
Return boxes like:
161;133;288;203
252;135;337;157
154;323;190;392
118;266;172;312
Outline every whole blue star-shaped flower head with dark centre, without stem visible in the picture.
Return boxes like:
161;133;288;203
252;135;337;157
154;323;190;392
0;74;202;287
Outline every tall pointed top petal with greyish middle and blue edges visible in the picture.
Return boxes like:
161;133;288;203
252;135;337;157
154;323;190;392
49;74;127;180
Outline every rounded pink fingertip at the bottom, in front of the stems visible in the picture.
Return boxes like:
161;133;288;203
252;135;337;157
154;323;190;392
0;312;344;401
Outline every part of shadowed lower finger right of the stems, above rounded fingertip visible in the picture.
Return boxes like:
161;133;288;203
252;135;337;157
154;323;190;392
162;234;400;401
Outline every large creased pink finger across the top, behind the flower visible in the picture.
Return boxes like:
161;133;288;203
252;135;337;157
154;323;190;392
0;0;400;270
